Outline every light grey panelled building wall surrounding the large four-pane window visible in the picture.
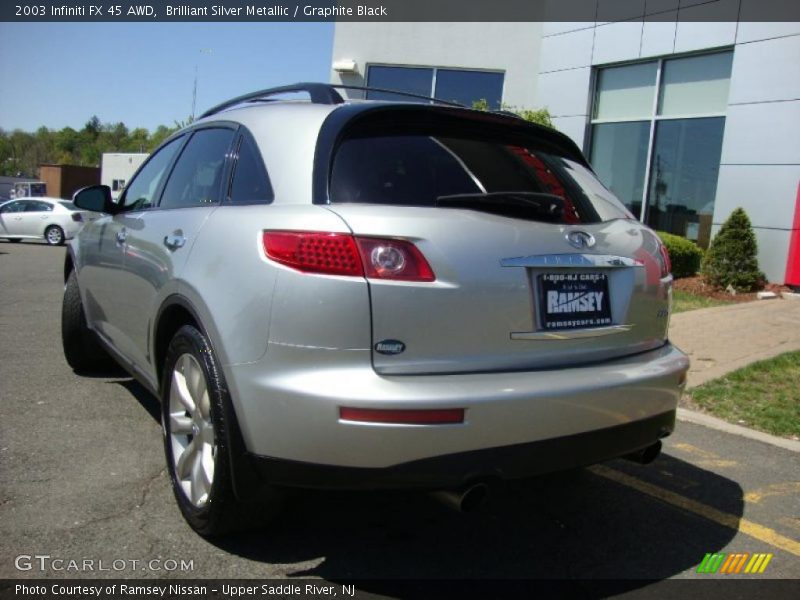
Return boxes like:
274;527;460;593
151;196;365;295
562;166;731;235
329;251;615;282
538;7;800;282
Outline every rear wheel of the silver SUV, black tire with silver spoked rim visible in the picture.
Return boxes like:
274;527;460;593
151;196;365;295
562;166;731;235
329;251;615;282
161;325;278;537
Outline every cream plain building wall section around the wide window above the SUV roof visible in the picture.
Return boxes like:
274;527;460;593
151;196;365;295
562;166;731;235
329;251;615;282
331;23;541;108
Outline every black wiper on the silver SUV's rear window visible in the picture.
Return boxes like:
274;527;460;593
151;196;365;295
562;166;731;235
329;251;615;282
436;192;564;223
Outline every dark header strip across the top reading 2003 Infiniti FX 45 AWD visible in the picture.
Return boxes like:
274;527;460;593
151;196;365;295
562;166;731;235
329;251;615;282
0;0;800;23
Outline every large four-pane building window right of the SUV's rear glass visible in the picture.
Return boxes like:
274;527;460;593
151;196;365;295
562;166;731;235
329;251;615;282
591;51;733;247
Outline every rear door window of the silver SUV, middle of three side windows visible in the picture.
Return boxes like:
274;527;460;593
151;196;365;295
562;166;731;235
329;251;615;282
159;129;234;208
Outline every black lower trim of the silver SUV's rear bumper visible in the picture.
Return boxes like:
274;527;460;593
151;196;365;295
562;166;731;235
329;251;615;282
248;411;675;490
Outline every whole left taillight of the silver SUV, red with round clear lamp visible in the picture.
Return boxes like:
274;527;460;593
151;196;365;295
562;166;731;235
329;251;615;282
263;231;436;281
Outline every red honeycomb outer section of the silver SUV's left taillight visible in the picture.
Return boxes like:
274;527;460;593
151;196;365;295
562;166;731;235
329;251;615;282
263;231;364;277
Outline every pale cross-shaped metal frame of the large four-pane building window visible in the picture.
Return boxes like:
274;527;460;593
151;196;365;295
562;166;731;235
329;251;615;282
583;46;734;223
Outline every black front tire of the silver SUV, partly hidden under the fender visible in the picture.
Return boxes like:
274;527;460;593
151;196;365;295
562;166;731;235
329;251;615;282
61;271;120;374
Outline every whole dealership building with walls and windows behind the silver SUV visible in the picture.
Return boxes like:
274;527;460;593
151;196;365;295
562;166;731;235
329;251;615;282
331;12;800;285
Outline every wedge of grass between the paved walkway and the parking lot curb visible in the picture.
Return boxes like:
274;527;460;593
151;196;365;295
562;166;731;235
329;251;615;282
690;352;800;437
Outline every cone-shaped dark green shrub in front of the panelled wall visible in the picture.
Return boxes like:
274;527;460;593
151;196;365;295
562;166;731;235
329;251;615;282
702;208;767;292
